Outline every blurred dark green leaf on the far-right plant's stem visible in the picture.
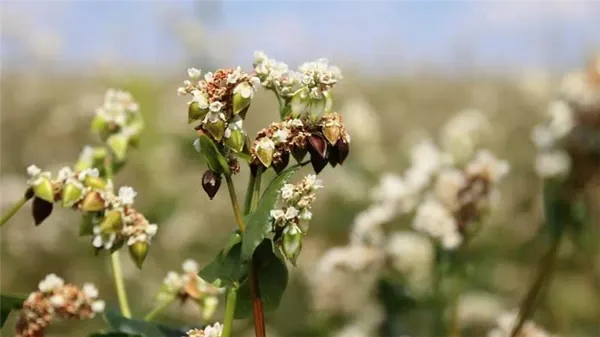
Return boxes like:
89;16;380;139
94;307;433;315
544;181;573;238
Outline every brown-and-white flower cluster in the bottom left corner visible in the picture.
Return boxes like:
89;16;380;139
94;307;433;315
15;274;105;337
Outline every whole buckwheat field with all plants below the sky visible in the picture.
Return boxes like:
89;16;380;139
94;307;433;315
0;8;600;337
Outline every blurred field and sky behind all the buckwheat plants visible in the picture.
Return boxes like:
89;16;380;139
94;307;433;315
0;0;600;337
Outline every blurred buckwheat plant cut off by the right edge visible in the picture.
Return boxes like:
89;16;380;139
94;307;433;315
511;56;600;337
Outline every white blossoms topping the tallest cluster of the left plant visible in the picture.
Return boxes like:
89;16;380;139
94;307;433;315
96;89;139;127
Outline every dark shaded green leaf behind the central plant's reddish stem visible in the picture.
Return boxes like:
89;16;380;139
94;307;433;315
235;240;288;319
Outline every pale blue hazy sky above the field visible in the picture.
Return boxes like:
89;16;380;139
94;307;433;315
0;0;600;72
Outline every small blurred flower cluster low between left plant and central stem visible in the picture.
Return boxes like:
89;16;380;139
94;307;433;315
158;259;224;319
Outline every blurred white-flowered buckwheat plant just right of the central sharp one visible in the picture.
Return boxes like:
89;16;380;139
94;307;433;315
312;110;509;336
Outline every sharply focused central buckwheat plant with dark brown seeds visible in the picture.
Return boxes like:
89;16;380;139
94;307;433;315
176;52;350;337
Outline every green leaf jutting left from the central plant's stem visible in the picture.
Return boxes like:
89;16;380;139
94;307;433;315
198;242;248;286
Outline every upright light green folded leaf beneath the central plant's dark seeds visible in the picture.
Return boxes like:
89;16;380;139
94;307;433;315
242;165;298;261
